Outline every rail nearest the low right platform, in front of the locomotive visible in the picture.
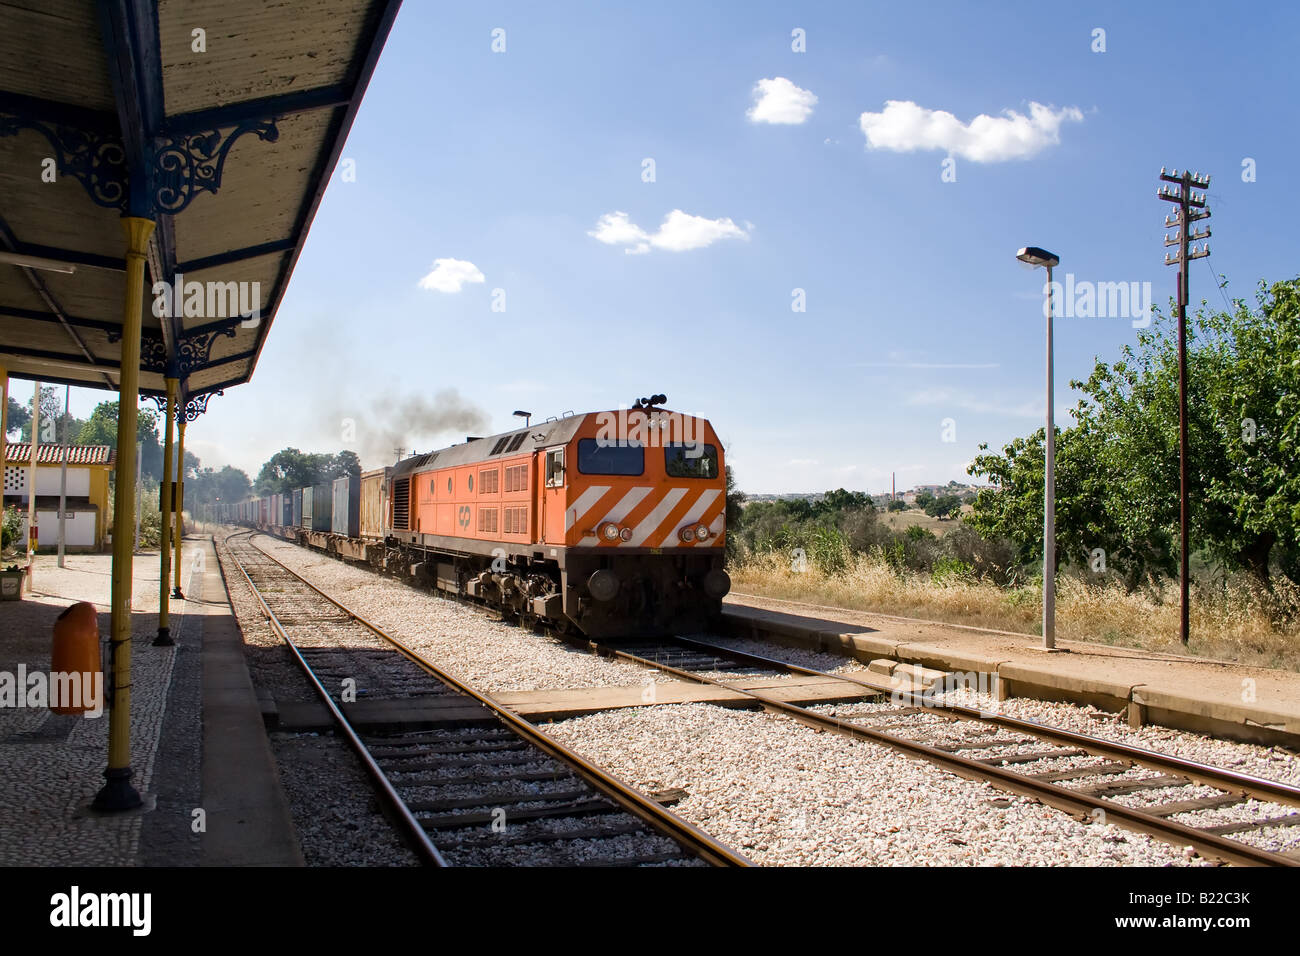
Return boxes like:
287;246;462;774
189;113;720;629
673;637;1300;806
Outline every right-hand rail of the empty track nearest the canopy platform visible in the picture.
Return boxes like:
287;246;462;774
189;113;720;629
236;532;754;866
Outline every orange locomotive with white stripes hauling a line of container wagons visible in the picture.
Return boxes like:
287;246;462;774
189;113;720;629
220;395;731;637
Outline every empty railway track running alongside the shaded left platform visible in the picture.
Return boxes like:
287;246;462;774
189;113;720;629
225;532;750;866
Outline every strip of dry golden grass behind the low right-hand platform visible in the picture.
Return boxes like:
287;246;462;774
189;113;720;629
729;553;1300;670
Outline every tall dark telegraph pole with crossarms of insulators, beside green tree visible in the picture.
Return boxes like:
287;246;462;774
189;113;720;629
1157;166;1210;645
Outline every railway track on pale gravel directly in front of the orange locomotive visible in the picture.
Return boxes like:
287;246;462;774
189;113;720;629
573;637;1300;866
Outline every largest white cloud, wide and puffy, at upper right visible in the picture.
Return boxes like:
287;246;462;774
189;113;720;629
858;100;1083;163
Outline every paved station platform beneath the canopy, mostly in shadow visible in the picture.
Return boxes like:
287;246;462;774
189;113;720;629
0;536;303;866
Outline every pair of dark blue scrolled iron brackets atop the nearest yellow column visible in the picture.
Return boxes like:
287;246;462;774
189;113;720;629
0;113;280;216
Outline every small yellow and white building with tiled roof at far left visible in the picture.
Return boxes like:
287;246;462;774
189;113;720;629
4;442;116;551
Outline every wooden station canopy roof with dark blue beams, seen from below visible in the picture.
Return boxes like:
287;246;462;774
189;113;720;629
0;0;399;398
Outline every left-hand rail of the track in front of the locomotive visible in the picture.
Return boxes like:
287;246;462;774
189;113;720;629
585;640;1300;866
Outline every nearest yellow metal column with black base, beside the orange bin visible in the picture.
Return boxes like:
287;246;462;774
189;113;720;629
94;216;152;810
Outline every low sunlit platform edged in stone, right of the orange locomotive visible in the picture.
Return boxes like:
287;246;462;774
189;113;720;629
724;594;1300;749
